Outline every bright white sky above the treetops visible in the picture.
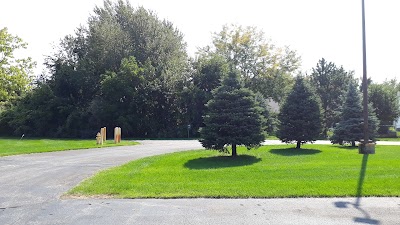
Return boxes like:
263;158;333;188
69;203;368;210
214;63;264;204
0;0;400;82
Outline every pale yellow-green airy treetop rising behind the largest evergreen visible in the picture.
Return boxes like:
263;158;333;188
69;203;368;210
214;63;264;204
199;25;300;102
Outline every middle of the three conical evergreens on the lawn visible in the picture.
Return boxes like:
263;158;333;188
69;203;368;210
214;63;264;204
277;76;322;148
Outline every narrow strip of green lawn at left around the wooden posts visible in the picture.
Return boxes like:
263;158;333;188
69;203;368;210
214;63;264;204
0;138;137;157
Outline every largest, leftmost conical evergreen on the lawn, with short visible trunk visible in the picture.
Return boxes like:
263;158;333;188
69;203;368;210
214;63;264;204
200;70;264;156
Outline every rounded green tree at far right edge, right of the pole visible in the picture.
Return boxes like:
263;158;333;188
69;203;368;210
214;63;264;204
368;80;400;134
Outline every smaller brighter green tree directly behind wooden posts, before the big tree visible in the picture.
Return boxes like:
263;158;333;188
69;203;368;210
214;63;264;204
94;56;145;136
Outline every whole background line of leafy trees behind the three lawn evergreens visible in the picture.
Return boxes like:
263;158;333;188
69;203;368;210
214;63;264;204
0;1;399;141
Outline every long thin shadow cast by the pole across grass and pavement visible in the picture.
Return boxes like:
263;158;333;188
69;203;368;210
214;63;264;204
334;154;380;225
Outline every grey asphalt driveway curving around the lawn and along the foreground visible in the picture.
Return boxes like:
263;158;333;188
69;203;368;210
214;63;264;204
0;141;400;225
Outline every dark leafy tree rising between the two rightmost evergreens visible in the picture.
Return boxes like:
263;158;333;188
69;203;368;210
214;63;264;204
310;58;354;137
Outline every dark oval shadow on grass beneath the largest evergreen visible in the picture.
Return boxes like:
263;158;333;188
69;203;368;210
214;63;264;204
184;155;261;170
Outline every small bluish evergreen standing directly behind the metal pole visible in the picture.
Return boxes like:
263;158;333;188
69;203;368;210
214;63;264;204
331;83;379;147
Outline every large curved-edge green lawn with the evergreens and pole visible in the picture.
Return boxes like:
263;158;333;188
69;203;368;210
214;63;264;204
68;144;400;198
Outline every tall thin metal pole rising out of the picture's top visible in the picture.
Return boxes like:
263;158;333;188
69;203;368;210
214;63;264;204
362;0;369;146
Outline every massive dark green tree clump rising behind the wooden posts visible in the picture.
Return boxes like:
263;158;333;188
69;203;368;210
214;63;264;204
0;0;190;137
